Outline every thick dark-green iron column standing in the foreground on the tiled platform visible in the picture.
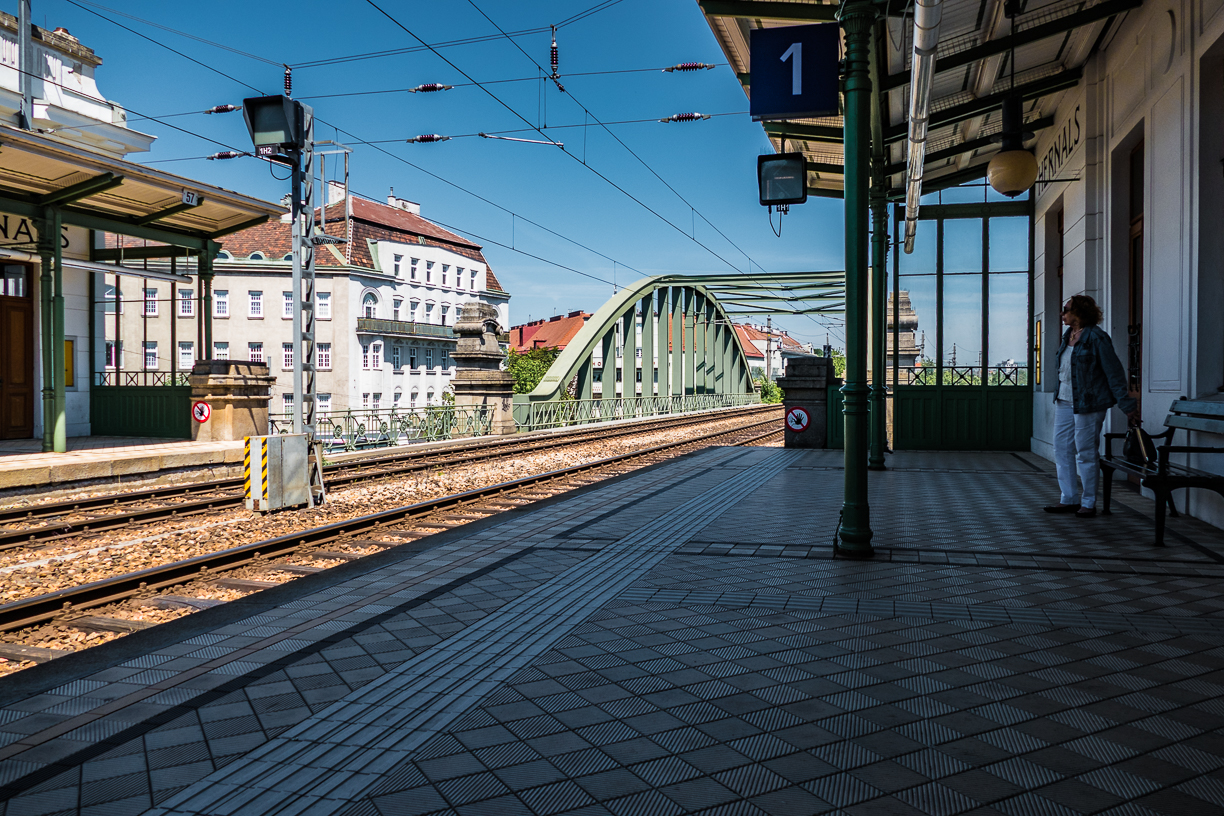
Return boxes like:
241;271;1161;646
837;0;876;558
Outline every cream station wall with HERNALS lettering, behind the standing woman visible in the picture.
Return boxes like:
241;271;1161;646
1032;0;1224;526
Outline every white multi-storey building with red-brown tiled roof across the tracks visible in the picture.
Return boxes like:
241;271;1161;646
115;194;510;416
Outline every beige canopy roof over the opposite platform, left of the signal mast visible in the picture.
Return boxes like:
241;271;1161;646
0;127;284;251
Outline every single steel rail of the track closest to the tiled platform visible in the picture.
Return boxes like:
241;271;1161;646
0;418;783;631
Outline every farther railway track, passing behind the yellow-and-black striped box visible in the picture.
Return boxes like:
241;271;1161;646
0;406;776;552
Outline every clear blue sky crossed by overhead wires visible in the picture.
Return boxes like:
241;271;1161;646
28;0;842;346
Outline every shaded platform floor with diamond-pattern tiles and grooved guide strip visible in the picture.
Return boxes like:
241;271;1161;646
0;448;1224;816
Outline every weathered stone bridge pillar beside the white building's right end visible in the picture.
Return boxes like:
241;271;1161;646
450;303;517;434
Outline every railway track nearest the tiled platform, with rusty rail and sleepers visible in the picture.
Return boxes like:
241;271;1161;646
0;417;782;661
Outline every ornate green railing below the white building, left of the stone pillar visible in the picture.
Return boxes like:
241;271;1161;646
268;405;493;453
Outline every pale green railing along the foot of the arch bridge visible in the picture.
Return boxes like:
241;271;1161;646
514;394;760;431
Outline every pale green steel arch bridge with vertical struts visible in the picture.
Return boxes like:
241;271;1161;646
514;272;845;428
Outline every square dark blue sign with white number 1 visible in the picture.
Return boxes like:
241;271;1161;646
749;23;840;121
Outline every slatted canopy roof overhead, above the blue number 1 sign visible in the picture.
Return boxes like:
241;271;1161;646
698;0;1142;199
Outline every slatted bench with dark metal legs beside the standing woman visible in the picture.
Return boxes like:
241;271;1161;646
1100;396;1224;547
